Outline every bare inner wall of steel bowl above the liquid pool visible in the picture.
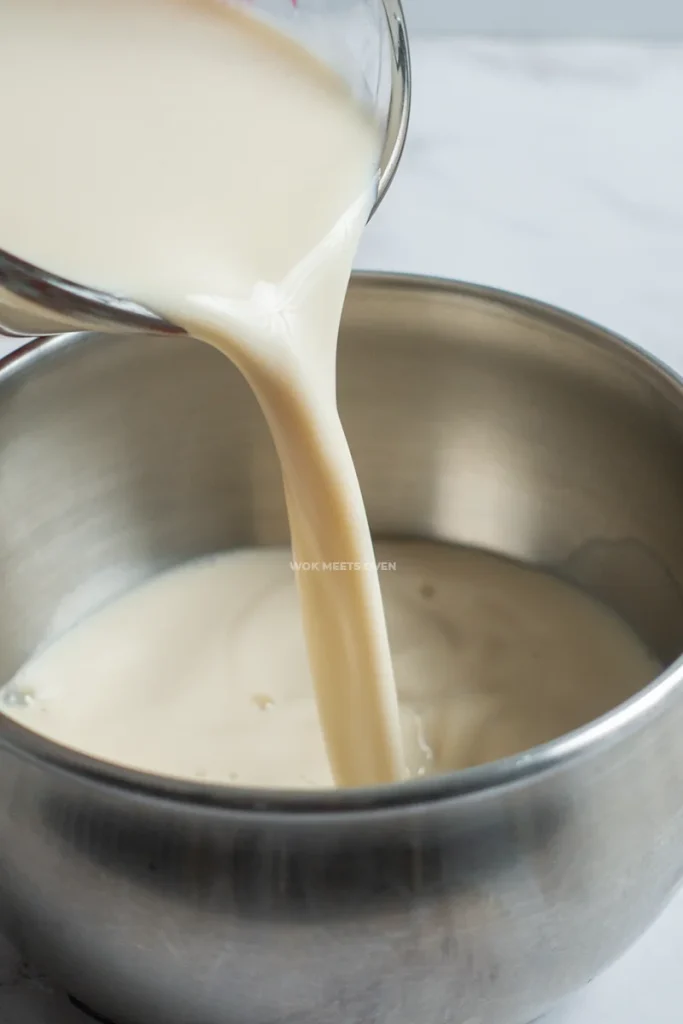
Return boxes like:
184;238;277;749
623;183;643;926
0;276;683;679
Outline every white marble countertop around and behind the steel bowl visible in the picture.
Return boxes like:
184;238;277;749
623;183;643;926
0;39;683;1024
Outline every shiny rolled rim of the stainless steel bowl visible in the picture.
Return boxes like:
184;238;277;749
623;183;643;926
0;272;683;820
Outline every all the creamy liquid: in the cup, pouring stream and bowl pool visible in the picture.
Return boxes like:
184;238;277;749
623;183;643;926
0;0;656;786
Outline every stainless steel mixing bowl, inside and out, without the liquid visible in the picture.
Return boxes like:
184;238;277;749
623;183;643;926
0;276;683;1024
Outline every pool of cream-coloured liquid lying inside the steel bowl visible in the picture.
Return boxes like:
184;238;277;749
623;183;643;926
6;543;658;788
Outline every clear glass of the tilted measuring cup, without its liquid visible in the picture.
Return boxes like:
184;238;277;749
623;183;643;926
0;0;412;338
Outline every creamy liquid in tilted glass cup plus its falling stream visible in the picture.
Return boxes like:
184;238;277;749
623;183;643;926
0;0;407;786
